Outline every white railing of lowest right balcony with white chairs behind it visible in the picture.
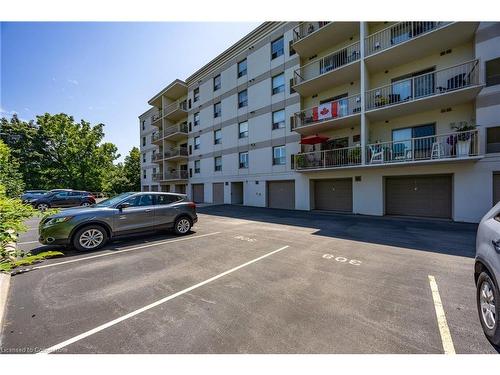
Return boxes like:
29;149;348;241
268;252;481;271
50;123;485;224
366;130;479;164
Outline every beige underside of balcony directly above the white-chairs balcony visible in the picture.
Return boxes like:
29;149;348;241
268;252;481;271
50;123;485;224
366;85;483;121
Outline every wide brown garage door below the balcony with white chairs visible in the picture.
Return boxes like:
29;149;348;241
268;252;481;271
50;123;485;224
385;175;452;219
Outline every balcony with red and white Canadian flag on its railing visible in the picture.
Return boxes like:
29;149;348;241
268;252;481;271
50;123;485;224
293;94;361;135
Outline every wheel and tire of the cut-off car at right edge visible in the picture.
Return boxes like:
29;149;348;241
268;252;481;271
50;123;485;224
476;272;500;346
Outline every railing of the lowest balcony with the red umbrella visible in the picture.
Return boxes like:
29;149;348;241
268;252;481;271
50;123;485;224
295;146;361;170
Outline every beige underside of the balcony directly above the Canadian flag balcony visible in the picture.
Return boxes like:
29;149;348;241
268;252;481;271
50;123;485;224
293;60;360;96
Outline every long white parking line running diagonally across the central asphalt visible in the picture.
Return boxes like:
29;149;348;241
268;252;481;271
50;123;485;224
39;245;289;354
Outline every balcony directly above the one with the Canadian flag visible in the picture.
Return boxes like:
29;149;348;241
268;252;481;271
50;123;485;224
293;42;361;96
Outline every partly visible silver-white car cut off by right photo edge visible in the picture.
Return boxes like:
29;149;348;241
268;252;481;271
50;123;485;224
474;202;500;346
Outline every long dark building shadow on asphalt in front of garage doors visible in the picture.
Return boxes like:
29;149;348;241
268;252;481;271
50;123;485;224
198;205;477;257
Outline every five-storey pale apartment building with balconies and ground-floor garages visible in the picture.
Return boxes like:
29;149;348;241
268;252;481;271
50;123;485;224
139;22;500;222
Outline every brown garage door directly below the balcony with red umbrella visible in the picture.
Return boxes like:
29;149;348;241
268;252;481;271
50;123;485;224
314;178;352;212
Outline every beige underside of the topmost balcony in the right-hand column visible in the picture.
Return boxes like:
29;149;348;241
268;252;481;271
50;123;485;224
365;22;479;72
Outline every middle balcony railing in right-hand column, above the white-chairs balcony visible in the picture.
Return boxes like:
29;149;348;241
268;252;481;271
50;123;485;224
366;60;479;110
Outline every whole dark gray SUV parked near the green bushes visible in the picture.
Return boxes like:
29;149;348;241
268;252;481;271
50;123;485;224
38;192;198;251
